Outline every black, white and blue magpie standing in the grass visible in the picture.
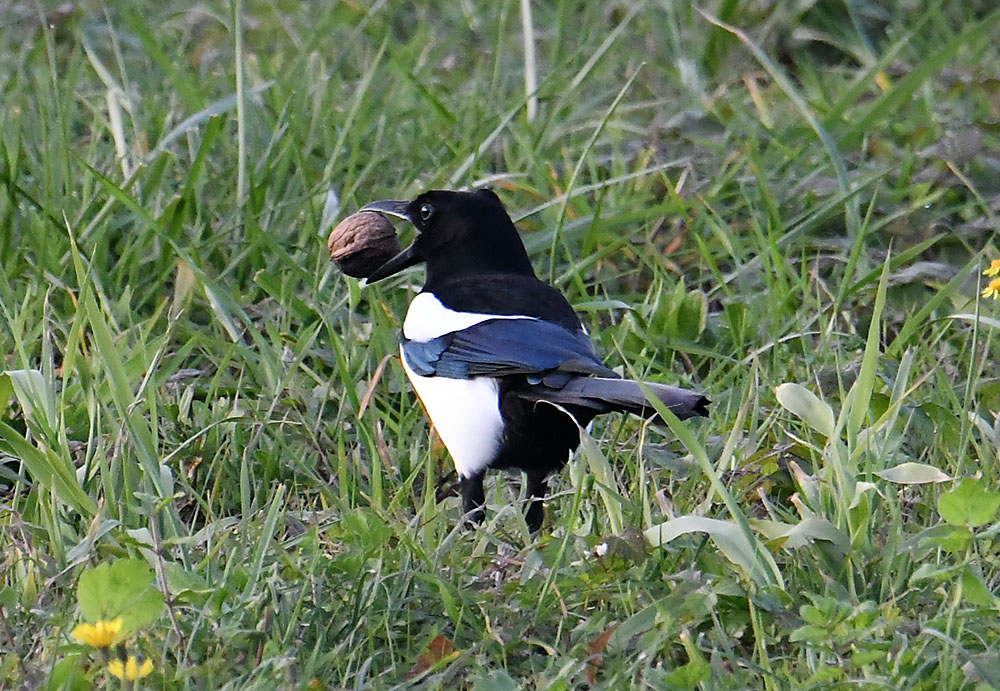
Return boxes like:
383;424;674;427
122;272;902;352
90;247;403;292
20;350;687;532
361;189;709;532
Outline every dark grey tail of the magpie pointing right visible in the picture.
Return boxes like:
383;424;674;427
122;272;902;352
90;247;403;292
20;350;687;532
520;377;710;420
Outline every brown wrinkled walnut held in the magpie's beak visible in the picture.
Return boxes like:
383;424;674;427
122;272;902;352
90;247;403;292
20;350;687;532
326;211;403;278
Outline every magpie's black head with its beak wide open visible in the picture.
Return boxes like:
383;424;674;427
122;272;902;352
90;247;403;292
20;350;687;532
361;189;535;284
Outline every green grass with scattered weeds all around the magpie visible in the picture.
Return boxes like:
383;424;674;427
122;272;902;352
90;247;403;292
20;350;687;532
0;0;1000;689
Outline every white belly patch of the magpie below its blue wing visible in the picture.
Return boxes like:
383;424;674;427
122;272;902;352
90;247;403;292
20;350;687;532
399;348;503;477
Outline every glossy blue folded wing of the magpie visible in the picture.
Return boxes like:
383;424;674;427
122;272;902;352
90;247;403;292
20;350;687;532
403;319;616;383
